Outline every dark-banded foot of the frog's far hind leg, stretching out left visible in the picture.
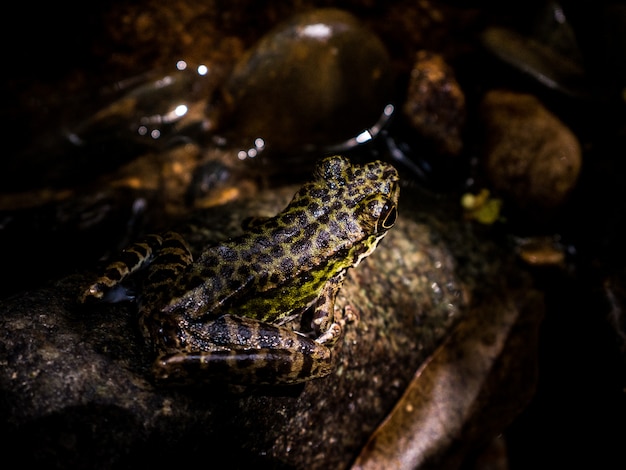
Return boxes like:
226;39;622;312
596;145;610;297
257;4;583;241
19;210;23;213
79;235;163;303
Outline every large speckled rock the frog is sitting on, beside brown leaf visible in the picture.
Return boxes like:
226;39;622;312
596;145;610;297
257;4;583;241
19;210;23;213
0;188;535;468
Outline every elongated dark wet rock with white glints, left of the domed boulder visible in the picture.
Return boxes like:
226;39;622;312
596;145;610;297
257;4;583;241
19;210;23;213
0;64;225;192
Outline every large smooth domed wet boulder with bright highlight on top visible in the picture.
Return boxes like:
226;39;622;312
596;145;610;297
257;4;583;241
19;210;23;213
209;9;391;158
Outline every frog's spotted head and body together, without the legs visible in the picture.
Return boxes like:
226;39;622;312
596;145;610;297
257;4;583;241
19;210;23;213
158;157;398;321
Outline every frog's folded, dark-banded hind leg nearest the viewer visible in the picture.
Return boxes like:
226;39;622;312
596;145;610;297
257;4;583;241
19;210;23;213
154;315;332;385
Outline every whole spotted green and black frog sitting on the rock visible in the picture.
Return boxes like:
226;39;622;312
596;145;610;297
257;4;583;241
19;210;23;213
80;155;400;385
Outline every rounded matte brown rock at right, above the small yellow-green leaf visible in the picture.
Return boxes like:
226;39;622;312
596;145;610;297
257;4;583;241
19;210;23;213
481;90;582;218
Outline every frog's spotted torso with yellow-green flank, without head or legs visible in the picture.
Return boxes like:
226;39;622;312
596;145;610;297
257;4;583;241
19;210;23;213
171;207;354;320
